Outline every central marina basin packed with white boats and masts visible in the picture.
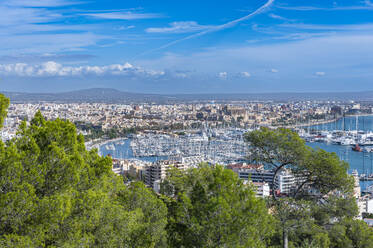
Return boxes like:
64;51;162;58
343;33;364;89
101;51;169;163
100;129;248;164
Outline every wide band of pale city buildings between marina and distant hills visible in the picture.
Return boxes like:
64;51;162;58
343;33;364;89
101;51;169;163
2;101;373;139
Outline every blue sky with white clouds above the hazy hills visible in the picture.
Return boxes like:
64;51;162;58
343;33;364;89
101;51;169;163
0;0;373;93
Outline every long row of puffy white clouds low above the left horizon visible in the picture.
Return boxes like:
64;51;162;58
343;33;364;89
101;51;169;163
0;61;165;77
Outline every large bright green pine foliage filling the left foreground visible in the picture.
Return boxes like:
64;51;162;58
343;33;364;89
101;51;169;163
0;112;167;247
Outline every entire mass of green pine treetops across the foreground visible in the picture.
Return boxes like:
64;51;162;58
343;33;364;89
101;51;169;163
0;94;373;248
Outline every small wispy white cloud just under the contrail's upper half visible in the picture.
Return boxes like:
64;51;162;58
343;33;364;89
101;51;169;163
145;21;213;34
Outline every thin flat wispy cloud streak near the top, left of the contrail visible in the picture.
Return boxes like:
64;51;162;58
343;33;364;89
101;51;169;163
81;11;162;20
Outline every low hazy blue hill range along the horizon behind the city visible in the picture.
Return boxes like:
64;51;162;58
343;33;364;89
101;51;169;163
2;88;373;103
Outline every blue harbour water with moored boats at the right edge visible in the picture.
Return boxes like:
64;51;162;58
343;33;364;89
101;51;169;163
297;115;373;189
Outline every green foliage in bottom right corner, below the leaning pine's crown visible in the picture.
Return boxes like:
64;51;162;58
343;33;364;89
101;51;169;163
270;197;373;248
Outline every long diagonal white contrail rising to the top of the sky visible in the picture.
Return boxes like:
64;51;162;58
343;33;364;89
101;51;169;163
136;0;275;57
